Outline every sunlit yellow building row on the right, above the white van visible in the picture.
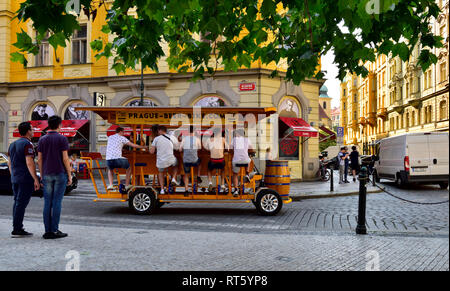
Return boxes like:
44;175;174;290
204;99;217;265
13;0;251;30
340;1;449;154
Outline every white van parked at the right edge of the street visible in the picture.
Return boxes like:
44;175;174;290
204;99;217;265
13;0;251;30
374;132;449;189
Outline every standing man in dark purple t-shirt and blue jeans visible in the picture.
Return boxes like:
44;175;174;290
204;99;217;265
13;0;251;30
38;115;72;239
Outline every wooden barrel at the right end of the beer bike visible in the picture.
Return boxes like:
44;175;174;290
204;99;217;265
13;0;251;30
264;161;291;198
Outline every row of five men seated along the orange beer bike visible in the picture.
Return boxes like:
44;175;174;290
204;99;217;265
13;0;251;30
106;125;254;197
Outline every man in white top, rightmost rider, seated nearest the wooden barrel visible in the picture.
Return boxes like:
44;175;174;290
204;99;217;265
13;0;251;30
232;128;254;196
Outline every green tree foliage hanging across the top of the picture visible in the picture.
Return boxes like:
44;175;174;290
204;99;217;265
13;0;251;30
11;0;442;84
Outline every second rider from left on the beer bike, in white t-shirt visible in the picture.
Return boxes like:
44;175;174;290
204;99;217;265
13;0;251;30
150;125;179;194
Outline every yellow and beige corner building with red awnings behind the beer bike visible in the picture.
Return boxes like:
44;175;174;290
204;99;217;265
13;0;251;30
0;0;328;181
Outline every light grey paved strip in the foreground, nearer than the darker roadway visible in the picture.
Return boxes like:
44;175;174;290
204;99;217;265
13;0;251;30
0;219;449;271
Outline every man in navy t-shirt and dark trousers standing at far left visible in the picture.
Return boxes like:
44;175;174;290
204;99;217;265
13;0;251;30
8;122;40;237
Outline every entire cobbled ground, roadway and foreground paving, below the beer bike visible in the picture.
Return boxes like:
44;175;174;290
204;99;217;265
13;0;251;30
0;183;449;270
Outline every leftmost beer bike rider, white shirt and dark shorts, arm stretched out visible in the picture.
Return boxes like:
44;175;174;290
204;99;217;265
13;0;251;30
106;126;147;191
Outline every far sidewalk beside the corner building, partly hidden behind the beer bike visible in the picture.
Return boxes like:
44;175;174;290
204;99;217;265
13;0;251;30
72;171;381;201
